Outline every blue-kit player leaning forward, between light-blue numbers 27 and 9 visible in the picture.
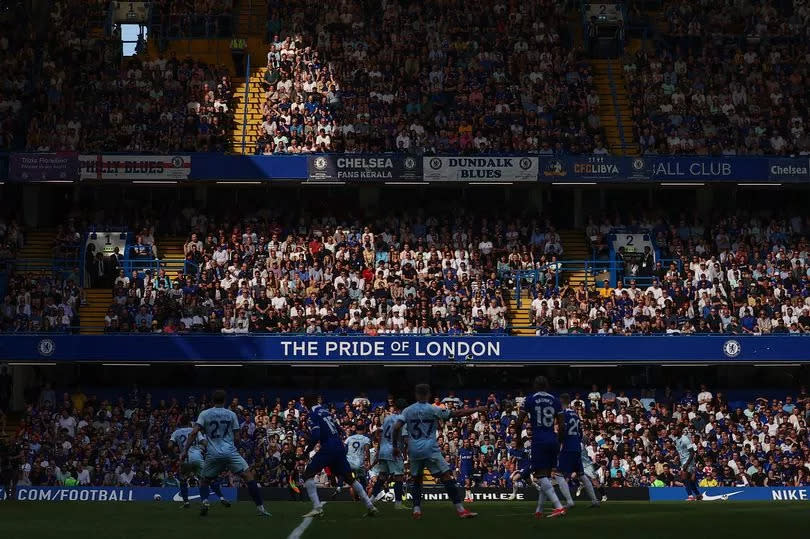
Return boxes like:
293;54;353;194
304;405;377;517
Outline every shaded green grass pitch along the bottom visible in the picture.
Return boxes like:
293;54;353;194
0;501;810;539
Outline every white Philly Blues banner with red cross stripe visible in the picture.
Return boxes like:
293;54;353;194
79;154;191;181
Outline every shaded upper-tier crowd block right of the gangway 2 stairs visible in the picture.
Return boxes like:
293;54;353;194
624;0;810;155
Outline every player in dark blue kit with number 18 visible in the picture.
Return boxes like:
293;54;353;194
517;376;565;518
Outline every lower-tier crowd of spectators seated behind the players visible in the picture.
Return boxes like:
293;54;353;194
7;385;810;488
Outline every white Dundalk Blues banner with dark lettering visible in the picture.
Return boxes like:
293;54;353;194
422;156;539;183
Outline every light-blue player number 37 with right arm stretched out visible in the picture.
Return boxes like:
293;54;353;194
392;384;487;519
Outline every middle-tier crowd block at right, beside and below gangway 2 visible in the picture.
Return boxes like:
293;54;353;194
531;214;810;335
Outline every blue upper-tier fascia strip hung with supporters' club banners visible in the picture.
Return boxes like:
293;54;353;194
6;153;810;183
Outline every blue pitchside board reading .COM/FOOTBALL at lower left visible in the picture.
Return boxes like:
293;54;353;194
0;486;237;502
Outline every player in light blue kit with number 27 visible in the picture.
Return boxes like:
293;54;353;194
180;389;270;517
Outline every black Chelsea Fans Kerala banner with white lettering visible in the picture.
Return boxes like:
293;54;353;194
307;154;422;182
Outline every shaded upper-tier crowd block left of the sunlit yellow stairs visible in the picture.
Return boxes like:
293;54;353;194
21;0;233;153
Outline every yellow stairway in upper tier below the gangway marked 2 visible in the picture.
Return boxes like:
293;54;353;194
591;58;639;155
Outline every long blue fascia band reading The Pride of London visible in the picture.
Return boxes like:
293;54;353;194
0;334;810;363
